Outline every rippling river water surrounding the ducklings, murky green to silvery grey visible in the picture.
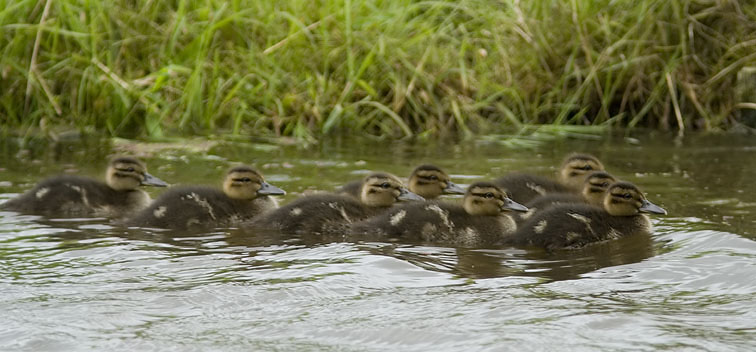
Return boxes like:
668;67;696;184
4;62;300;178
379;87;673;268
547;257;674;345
0;136;756;351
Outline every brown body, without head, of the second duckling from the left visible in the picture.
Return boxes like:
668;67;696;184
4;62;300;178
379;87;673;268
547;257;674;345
118;186;275;229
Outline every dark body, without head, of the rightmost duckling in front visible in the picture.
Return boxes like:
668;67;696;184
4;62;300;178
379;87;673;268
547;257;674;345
506;204;651;249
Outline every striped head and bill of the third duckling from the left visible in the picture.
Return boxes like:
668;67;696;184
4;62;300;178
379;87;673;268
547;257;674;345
360;172;424;207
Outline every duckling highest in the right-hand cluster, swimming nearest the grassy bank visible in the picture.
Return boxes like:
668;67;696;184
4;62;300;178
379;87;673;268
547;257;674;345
494;154;604;204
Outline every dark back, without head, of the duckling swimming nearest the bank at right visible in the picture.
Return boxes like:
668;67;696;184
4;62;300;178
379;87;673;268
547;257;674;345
494;173;572;204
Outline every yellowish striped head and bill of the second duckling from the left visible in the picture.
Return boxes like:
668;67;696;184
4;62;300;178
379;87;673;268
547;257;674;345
223;166;286;200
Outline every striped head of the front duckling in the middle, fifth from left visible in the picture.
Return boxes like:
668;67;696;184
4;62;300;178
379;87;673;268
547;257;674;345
464;182;528;216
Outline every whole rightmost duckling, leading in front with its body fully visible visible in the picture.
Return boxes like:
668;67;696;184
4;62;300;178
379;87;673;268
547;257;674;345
506;182;667;249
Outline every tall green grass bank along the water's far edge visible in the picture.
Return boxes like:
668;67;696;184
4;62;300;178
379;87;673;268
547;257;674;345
0;0;756;138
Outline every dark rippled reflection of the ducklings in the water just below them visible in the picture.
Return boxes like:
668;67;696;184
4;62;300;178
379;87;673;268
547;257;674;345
0;209;658;280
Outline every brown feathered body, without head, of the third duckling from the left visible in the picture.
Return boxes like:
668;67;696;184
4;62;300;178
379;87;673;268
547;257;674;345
249;194;383;234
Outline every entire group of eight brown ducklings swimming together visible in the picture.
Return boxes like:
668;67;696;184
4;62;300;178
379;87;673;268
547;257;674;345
0;154;666;249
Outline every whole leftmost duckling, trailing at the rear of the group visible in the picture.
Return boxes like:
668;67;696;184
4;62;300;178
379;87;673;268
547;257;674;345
0;156;167;218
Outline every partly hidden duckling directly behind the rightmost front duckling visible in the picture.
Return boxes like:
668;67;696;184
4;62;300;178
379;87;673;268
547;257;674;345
515;171;617;223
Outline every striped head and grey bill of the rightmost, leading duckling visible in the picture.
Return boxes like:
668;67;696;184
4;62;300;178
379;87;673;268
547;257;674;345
604;182;667;216
